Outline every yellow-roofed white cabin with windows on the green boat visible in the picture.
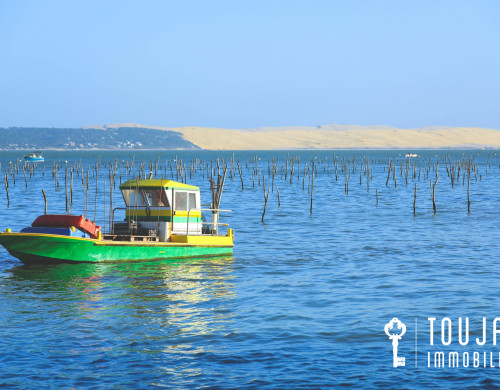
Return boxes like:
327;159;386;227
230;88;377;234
113;179;203;241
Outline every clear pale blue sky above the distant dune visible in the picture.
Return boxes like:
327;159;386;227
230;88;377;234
0;0;500;129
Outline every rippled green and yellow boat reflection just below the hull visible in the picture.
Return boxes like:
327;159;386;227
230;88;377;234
7;256;233;314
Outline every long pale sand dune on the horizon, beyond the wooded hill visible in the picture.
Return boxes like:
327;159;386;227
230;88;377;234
91;123;500;150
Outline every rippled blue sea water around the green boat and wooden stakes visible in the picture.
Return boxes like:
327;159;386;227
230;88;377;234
0;151;500;389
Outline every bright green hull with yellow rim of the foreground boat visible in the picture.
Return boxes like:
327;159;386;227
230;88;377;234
0;233;233;264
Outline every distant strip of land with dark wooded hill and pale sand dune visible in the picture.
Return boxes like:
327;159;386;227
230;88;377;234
0;123;500;151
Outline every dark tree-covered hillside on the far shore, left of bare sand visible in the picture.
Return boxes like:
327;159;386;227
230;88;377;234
0;127;199;150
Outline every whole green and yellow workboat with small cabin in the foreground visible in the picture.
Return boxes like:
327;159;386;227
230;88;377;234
0;179;234;264
